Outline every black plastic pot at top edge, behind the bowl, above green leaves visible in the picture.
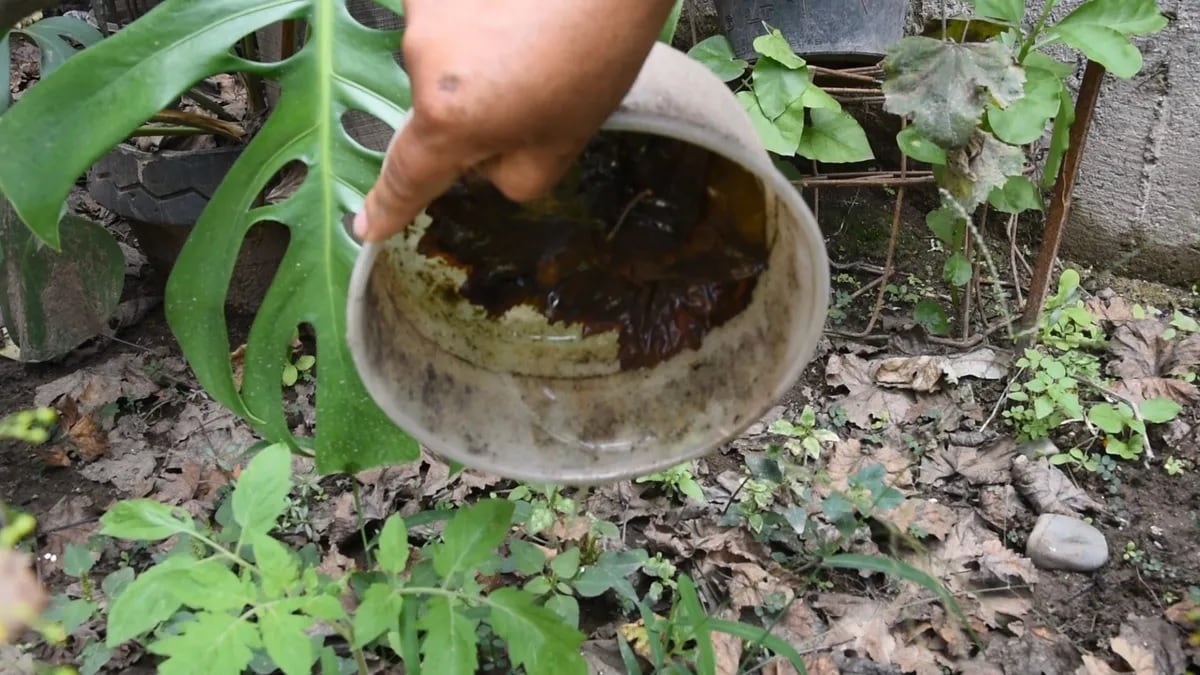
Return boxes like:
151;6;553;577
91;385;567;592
716;0;910;64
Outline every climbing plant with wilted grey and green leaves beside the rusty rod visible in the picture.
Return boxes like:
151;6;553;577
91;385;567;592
883;0;1166;327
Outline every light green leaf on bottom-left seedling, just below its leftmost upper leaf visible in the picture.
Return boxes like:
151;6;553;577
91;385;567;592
104;556;197;647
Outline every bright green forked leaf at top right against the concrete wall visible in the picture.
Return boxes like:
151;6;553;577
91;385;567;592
1045;0;1168;78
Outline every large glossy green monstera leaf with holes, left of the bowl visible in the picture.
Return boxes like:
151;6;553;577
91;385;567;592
0;0;418;472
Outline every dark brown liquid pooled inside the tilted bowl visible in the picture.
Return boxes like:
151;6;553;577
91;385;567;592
418;127;767;370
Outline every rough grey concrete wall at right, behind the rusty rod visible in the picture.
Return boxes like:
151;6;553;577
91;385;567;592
680;0;1200;283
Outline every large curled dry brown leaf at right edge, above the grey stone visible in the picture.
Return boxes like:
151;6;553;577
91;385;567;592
1108;319;1200;405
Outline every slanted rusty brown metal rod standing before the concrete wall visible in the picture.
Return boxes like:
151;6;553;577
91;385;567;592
1020;60;1105;333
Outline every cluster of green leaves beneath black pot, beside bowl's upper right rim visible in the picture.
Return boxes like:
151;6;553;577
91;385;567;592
688;29;875;163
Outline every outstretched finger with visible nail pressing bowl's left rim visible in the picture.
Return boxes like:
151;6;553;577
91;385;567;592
354;118;464;243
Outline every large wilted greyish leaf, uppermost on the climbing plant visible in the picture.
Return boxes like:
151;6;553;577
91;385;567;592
883;36;1025;149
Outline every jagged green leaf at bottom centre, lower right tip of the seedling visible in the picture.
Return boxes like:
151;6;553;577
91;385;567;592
487;589;588;675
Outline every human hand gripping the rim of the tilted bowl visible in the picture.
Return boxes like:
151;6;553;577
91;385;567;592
354;0;673;241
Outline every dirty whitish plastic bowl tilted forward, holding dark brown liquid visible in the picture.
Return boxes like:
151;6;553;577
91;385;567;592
348;44;829;484
